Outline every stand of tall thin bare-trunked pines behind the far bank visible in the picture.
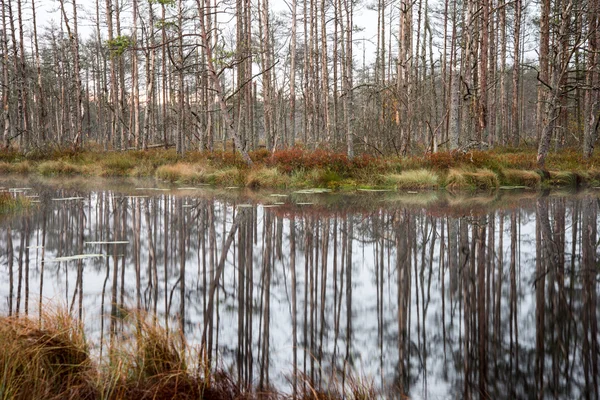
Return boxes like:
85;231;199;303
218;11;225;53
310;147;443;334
0;0;600;167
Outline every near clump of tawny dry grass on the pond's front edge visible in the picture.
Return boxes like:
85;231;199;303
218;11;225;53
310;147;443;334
0;313;377;400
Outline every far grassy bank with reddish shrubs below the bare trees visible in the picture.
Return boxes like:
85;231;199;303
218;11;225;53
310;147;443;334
0;148;600;190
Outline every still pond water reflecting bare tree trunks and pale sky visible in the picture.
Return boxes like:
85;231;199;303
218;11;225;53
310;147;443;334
0;181;600;399
